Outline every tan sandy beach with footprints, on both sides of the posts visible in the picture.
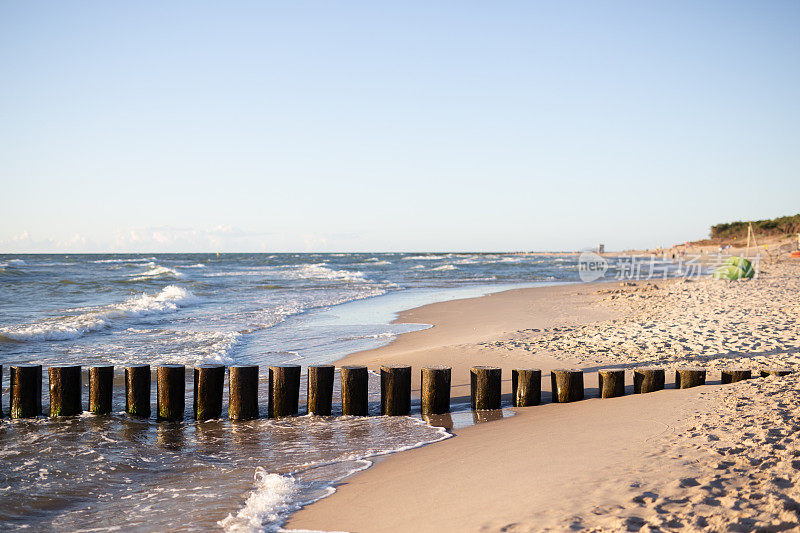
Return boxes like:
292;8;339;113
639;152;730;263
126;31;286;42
287;263;800;531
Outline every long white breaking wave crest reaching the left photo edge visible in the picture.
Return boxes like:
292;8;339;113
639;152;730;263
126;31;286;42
0;285;198;341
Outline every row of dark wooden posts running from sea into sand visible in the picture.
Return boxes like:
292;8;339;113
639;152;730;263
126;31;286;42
0;365;790;420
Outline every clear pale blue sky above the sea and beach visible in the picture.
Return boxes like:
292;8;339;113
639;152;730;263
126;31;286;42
0;0;800;253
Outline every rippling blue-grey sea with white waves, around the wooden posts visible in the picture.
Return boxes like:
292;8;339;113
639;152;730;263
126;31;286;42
0;253;608;531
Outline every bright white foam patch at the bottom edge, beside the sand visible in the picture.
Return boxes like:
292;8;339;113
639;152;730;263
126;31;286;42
217;466;298;533
